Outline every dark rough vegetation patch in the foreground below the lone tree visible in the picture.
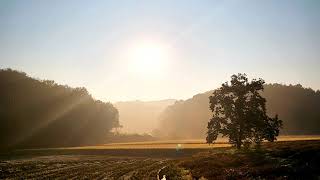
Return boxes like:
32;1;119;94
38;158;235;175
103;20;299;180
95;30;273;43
178;140;320;179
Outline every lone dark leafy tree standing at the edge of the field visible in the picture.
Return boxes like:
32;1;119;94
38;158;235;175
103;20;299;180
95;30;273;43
206;74;282;149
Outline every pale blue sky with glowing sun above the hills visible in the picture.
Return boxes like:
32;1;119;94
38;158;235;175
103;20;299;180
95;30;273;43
0;0;320;102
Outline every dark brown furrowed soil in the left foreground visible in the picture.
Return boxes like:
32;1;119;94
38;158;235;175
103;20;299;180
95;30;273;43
0;155;167;179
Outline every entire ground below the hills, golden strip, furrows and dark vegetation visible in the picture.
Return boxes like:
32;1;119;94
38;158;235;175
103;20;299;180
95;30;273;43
0;137;320;179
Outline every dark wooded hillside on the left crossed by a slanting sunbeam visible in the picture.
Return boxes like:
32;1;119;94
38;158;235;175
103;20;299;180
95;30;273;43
0;69;120;149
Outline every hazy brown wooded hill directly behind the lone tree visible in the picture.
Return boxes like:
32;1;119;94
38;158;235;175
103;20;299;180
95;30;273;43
157;84;320;138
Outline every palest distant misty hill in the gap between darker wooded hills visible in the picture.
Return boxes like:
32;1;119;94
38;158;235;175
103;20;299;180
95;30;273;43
114;99;176;134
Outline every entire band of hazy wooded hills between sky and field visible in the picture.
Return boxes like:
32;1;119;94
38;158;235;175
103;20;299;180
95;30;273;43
0;70;320;150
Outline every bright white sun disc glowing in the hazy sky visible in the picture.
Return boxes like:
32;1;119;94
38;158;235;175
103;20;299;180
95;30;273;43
129;43;168;77
